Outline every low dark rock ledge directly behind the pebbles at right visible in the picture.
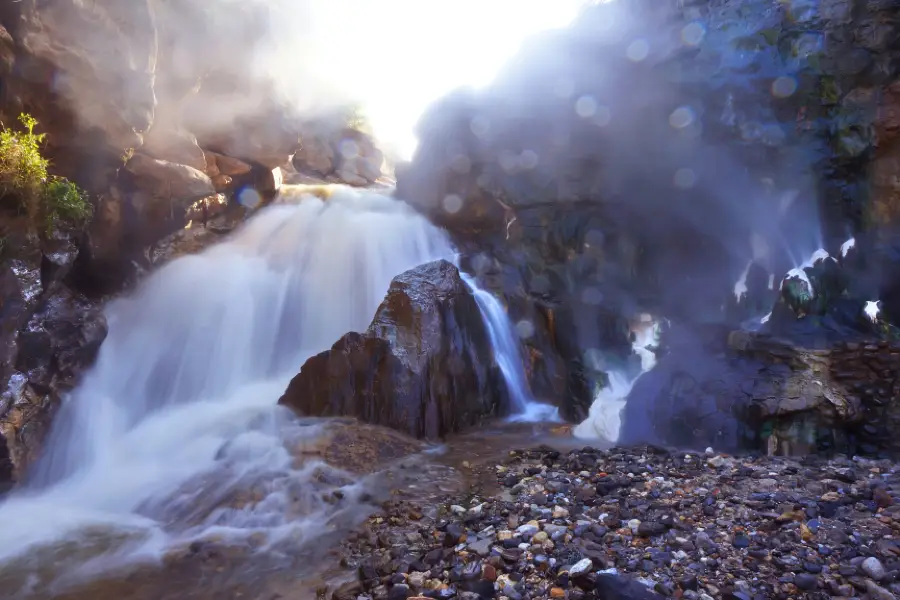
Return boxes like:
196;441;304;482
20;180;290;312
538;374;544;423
620;327;900;454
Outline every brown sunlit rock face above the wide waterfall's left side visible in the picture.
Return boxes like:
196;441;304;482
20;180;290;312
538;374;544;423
0;0;383;295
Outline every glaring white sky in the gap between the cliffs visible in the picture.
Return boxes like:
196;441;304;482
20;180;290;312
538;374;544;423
278;0;586;155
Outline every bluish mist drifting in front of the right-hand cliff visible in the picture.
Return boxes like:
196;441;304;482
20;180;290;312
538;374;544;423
401;0;846;328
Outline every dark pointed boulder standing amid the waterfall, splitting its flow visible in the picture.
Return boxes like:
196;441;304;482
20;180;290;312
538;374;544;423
279;261;509;439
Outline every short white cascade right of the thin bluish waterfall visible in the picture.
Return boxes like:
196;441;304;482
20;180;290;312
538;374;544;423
572;315;659;443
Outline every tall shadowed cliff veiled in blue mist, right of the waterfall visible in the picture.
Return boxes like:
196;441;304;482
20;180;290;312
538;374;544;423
397;0;900;424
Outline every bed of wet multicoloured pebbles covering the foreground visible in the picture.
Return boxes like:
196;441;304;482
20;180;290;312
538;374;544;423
338;447;900;600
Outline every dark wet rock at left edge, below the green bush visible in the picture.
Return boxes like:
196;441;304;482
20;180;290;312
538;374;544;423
0;217;106;487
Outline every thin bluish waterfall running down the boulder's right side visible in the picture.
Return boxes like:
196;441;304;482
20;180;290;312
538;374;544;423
460;271;559;422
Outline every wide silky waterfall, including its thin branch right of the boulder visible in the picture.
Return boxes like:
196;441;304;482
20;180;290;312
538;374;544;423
0;188;552;592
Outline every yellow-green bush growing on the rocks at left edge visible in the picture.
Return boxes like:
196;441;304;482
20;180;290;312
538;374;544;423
0;114;92;234
